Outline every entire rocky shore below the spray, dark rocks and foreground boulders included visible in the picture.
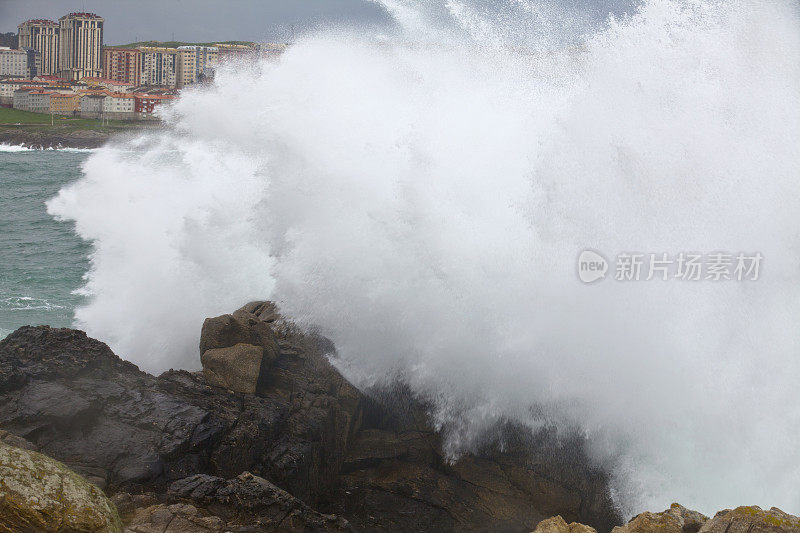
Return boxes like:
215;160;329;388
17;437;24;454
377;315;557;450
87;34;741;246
0;303;800;533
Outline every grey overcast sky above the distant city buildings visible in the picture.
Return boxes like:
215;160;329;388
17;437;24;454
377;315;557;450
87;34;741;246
0;0;388;44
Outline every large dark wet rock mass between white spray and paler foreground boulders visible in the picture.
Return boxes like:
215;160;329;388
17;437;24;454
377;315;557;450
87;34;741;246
0;302;619;531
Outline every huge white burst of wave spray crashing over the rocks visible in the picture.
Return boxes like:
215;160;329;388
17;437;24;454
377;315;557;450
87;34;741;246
49;0;800;514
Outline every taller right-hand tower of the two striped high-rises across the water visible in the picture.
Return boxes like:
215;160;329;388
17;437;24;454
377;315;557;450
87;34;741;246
58;13;104;80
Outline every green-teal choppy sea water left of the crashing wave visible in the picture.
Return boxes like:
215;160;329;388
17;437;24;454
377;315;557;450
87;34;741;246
0;145;90;338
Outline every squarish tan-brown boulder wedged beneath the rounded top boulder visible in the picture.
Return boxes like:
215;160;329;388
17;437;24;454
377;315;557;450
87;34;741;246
202;344;264;394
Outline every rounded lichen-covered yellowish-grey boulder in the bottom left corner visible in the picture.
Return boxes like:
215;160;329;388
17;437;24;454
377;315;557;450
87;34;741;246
0;443;122;533
